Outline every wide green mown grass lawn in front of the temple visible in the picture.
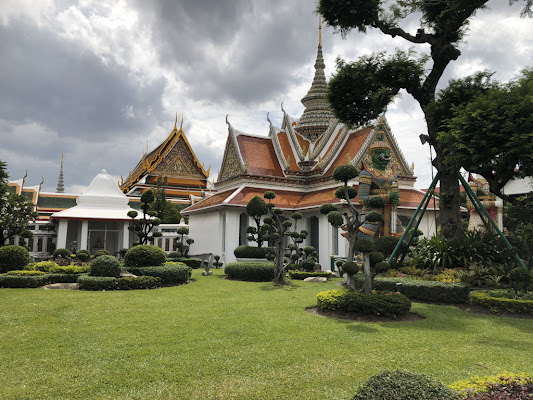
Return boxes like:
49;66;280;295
0;270;533;400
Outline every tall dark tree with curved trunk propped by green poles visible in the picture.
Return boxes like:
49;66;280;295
317;0;532;238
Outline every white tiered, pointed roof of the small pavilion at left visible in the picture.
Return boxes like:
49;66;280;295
51;169;140;221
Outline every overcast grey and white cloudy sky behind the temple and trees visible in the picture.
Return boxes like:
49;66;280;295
0;0;533;193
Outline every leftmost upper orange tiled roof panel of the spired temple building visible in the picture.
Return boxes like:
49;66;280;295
237;135;284;176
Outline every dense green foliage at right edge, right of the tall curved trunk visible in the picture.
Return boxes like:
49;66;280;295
435;69;533;201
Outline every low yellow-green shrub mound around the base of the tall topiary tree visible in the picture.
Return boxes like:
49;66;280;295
317;289;411;318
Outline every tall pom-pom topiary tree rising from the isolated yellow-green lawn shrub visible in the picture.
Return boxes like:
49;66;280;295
320;164;383;293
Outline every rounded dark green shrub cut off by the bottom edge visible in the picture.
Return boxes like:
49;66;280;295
353;371;457;400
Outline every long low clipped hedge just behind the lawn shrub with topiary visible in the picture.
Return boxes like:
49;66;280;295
354;274;470;304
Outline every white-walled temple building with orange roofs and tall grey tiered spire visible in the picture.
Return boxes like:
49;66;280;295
182;22;436;269
